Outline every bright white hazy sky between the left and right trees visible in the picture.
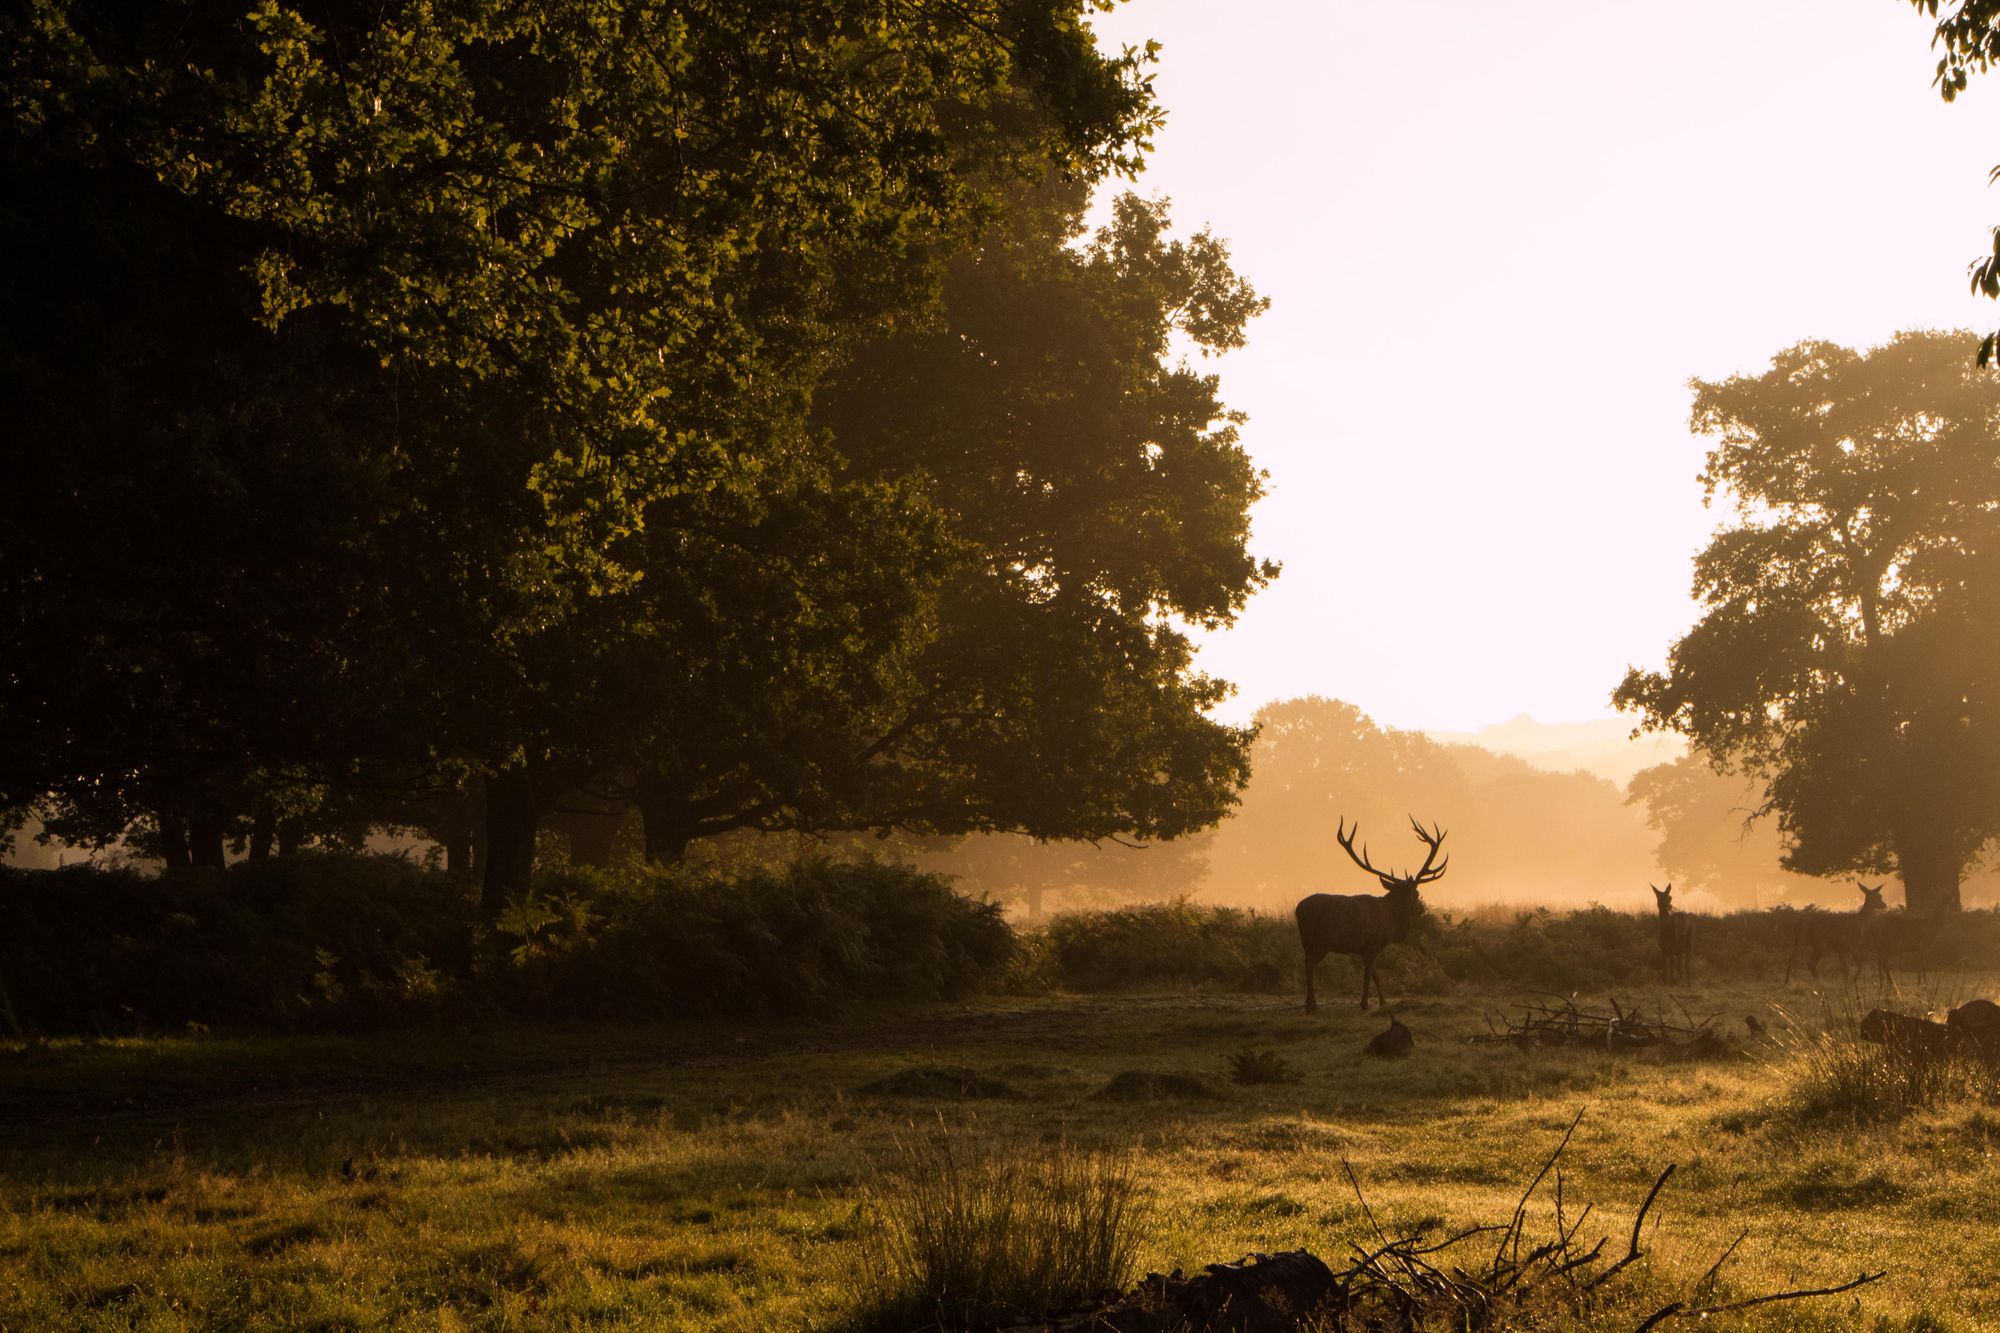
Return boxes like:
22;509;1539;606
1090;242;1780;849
1098;0;2000;731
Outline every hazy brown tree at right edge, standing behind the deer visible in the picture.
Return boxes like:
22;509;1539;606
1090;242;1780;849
1614;332;2000;915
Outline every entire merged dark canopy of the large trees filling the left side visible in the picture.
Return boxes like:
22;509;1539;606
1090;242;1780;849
0;0;1274;897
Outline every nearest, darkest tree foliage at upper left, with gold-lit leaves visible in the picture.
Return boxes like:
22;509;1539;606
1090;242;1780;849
0;0;1192;896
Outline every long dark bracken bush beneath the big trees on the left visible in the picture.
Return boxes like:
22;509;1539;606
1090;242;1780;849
0;853;1014;1035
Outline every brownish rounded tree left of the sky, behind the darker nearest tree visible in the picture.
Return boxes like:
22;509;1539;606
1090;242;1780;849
556;180;1274;872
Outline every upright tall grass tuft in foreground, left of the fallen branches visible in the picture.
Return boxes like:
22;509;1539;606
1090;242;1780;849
862;1129;1142;1329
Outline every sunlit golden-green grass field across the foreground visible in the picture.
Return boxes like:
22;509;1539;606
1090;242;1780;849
0;967;2000;1329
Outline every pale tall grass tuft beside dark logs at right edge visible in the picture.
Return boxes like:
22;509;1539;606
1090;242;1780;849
1776;997;2000;1125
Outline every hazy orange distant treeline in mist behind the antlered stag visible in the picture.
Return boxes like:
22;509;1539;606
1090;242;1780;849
894;699;2000;917
